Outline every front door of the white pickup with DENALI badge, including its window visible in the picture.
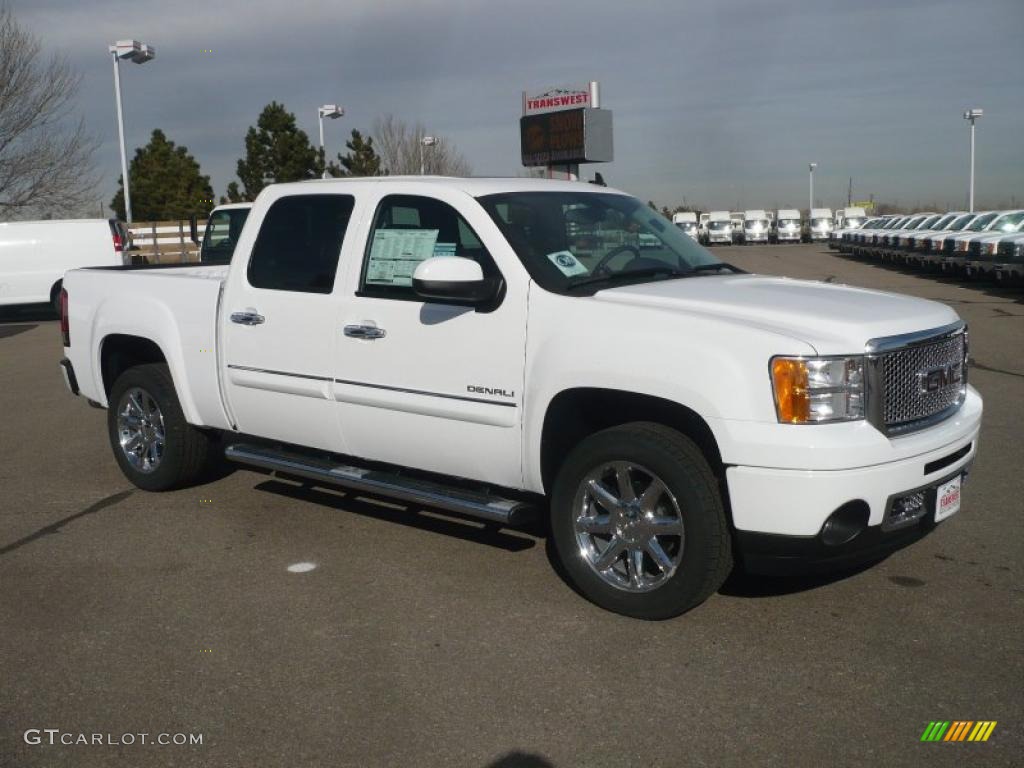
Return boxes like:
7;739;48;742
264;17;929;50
334;187;528;486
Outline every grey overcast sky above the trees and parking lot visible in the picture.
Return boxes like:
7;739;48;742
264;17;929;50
8;0;1024;214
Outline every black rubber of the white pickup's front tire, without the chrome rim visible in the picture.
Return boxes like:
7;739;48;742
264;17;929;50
551;422;732;620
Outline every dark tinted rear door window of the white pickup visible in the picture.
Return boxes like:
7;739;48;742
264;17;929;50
249;195;354;293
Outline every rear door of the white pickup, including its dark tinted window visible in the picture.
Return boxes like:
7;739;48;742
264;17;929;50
220;193;356;453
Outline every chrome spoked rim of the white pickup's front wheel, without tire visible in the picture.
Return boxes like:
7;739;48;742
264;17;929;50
573;462;684;592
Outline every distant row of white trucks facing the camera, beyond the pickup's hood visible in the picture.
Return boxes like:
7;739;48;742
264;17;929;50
672;207;865;246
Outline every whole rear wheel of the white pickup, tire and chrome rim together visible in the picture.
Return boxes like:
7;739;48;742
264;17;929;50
106;362;217;490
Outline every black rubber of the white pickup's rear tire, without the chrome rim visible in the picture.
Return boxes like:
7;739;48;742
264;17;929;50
106;362;218;490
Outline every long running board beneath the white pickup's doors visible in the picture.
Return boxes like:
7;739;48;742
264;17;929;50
224;443;535;525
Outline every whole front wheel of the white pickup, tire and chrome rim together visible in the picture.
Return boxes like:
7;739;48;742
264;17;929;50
551;422;732;620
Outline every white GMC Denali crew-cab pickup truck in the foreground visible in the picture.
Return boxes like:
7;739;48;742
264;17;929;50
60;177;982;618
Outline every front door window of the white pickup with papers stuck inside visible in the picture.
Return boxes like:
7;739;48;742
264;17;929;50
359;195;498;301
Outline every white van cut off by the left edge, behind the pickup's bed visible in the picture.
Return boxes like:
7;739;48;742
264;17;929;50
0;219;130;310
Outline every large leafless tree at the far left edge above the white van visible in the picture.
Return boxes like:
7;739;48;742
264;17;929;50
0;6;97;219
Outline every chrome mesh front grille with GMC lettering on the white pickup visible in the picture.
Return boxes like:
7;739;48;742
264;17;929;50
867;323;967;434
